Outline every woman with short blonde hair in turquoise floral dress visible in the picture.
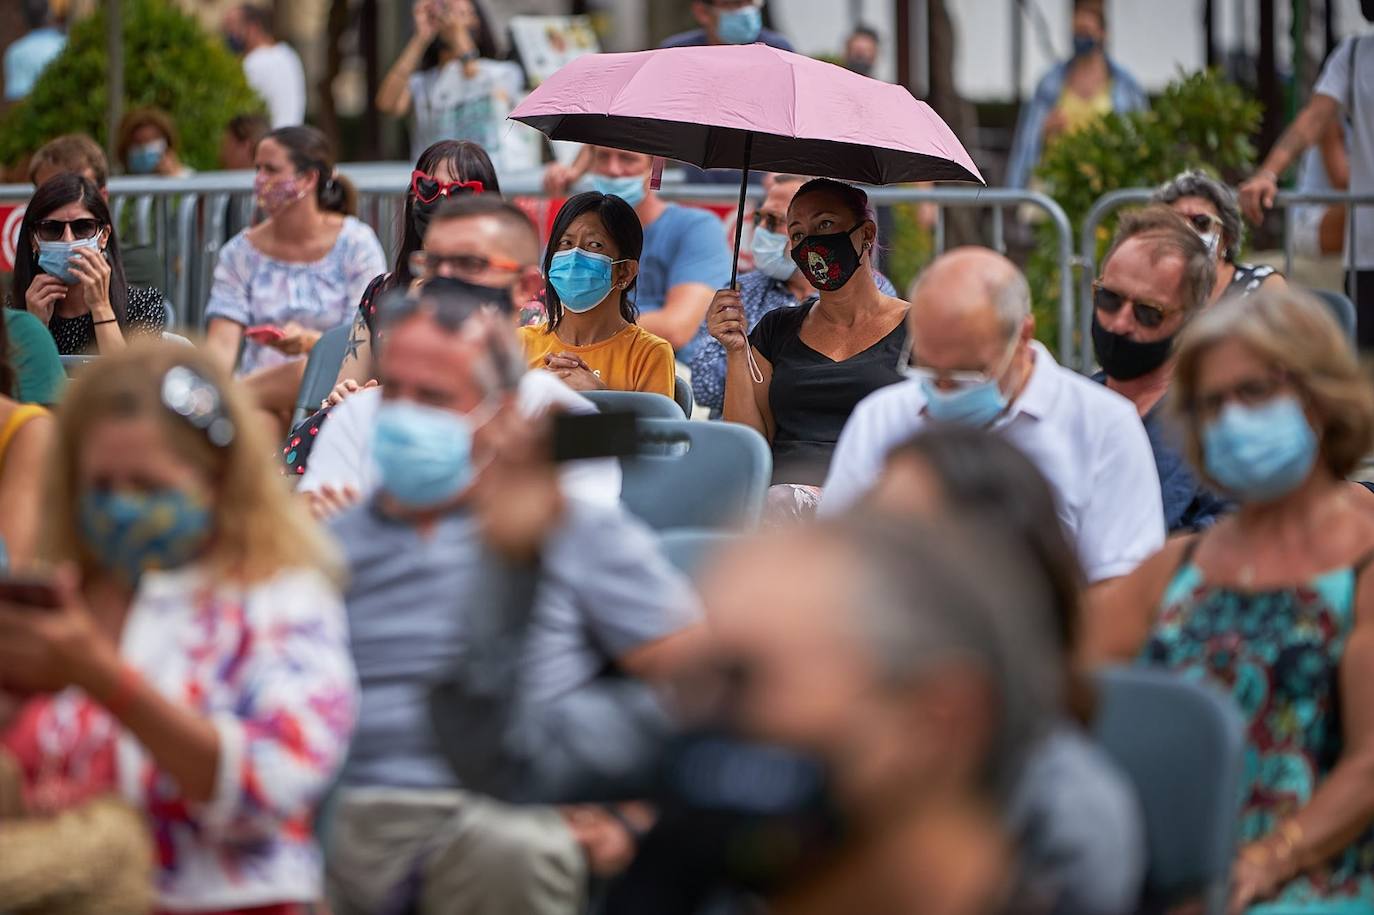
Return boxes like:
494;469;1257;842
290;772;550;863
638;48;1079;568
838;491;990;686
1090;291;1374;912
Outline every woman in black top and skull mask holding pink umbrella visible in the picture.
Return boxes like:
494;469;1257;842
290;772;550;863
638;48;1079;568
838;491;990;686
706;179;907;514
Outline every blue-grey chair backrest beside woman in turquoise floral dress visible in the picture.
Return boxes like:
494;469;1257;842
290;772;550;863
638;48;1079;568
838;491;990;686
1094;668;1245;915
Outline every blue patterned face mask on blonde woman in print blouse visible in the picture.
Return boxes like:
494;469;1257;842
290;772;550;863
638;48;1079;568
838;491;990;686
80;489;214;584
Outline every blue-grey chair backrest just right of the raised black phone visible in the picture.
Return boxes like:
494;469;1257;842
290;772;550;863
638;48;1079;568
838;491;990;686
620;417;772;530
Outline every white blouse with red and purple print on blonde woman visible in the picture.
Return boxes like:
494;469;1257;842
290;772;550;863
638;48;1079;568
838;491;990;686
0;566;357;912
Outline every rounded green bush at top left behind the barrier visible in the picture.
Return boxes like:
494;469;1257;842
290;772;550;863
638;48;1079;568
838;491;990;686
0;0;262;169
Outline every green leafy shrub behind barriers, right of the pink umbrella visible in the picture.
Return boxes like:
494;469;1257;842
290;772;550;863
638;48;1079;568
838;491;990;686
1026;70;1261;342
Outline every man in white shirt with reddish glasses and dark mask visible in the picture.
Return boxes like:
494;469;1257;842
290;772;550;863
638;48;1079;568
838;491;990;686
303;194;621;518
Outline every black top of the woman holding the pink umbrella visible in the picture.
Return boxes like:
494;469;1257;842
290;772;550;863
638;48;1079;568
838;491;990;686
749;301;907;486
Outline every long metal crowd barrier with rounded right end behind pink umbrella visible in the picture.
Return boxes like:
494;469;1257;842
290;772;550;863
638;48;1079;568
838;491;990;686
0;162;1077;364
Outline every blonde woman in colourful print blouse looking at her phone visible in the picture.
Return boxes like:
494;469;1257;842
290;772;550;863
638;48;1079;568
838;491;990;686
0;342;357;915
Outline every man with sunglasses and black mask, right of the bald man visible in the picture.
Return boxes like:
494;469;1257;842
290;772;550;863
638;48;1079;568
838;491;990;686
1092;206;1230;533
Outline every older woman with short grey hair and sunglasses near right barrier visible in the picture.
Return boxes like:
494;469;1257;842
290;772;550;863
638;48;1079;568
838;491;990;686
1151;172;1287;302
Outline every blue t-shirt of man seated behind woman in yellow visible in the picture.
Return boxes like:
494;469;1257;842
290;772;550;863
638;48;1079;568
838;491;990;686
635;203;731;361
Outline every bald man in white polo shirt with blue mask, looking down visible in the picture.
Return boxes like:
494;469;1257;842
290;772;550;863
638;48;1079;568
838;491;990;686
820;247;1164;585
